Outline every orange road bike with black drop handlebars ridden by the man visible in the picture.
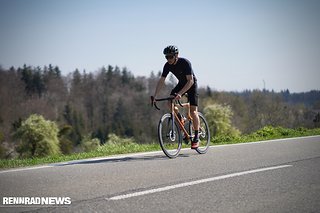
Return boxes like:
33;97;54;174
151;96;210;158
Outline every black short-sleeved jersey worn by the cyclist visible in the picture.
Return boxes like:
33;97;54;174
162;58;197;85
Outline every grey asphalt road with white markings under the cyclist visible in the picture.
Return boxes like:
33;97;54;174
0;136;320;213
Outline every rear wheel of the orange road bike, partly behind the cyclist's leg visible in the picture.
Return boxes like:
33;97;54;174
189;112;210;154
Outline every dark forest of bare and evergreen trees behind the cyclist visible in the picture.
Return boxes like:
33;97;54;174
0;65;320;157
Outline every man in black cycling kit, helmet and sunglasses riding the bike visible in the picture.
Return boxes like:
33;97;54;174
154;45;200;149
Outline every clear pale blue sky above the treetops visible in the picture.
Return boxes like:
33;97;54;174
0;0;320;92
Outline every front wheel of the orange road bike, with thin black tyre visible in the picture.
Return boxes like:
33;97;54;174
158;113;182;158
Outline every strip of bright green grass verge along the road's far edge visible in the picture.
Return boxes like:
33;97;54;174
0;126;320;169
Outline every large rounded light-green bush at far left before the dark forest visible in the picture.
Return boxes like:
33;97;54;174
15;114;60;157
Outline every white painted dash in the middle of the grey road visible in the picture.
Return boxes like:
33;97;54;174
106;165;292;200
